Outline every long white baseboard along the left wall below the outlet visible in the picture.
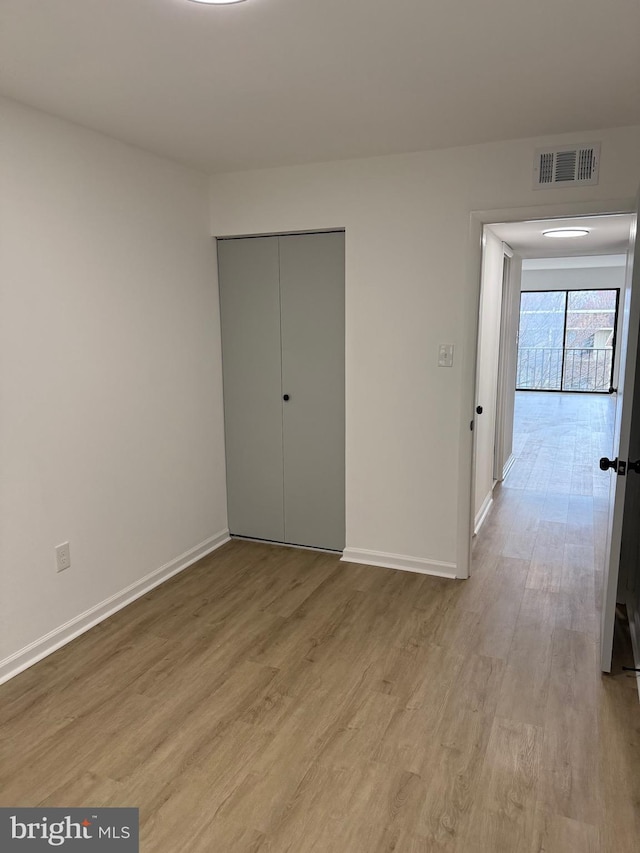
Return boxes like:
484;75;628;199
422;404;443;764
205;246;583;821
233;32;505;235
0;530;229;684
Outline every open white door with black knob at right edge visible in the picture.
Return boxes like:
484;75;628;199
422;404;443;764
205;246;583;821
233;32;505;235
600;200;640;672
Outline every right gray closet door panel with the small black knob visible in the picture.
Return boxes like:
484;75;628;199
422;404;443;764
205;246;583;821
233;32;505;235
278;232;345;551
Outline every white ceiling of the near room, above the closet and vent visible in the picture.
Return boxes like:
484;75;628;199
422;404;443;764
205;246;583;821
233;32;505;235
0;0;640;171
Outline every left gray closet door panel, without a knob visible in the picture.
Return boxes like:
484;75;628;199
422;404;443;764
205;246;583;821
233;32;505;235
218;237;284;542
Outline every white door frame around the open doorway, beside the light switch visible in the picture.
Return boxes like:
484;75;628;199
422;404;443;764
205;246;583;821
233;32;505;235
456;196;636;578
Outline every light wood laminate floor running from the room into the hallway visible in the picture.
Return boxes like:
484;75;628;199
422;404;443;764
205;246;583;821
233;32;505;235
0;393;640;853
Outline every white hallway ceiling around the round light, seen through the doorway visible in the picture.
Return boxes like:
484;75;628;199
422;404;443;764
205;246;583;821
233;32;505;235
490;214;635;258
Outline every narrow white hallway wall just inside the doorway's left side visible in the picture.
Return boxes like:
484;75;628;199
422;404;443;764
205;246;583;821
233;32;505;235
473;227;504;531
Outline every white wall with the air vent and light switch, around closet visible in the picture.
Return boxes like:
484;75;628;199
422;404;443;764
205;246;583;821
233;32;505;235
211;127;640;574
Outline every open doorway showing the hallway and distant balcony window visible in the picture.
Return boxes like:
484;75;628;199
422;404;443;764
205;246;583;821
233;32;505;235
471;214;635;672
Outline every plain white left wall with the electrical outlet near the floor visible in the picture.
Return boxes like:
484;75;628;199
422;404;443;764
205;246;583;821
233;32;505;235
0;96;227;678
